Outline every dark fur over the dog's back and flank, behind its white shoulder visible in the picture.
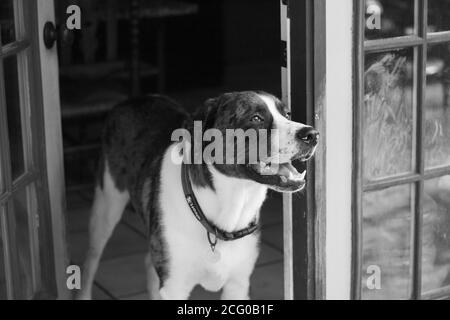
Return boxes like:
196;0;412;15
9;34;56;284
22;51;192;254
98;95;189;285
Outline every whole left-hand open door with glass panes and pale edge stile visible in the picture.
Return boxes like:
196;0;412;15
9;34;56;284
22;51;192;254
0;0;67;299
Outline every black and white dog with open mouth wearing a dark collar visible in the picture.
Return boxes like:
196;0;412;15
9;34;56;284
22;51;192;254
78;92;318;299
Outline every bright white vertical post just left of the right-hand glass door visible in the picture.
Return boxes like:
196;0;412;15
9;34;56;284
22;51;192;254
325;0;354;300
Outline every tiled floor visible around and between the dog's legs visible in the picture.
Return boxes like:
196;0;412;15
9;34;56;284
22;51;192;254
67;191;283;300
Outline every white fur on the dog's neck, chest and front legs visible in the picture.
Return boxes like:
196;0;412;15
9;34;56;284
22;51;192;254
159;145;267;299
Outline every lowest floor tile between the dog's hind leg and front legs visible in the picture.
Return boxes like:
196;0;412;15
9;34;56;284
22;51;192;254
96;253;147;297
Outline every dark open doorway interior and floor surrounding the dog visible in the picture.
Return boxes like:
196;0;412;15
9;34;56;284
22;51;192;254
59;0;284;300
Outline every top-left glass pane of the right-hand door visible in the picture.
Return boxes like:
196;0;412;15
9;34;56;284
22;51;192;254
365;0;414;40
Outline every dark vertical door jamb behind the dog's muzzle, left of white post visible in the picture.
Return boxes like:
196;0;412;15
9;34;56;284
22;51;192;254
280;0;326;300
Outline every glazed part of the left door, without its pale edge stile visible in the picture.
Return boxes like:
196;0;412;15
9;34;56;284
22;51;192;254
0;0;64;299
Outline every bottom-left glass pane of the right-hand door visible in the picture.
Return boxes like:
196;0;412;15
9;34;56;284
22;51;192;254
361;185;413;299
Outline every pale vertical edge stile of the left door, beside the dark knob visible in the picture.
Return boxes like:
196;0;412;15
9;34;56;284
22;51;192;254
36;0;70;299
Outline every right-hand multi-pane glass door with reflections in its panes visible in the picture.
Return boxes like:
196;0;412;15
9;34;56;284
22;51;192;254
353;0;450;299
